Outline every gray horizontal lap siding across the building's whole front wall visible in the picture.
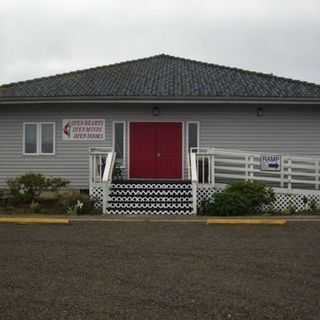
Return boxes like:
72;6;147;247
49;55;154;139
0;104;320;188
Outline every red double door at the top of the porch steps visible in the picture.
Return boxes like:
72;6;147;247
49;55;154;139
130;122;182;179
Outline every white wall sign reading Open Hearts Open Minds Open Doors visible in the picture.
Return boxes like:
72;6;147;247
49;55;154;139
62;119;106;141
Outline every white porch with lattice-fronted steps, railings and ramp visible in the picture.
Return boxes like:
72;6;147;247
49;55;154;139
90;148;320;214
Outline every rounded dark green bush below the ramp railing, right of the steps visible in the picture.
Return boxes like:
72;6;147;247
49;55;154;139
207;181;275;216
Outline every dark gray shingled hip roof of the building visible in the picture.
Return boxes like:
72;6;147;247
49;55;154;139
0;54;320;99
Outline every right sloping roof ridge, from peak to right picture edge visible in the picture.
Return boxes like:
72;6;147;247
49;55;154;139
159;54;320;88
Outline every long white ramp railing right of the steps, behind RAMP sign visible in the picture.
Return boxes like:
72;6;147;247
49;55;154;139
190;148;320;192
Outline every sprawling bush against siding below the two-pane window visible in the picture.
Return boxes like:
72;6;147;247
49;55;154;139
7;173;69;204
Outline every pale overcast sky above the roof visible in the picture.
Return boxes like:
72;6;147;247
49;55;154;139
0;0;320;84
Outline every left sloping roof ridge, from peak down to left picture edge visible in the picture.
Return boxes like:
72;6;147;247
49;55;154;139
0;54;165;89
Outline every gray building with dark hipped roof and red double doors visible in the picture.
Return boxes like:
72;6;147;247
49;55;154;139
0;55;320;215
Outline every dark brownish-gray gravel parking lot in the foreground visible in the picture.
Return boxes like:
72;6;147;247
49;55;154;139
0;222;320;320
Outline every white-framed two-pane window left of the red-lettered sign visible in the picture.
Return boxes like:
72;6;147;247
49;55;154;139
23;122;55;155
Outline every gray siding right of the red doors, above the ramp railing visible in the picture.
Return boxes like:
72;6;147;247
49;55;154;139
200;106;320;156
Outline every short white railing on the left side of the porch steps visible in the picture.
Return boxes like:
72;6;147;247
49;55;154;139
89;148;116;213
